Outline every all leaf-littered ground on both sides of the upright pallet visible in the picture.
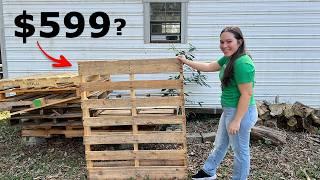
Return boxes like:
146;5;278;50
0;117;320;180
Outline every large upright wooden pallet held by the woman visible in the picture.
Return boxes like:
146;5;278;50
79;59;187;179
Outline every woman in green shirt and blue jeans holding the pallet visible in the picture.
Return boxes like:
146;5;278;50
177;26;257;180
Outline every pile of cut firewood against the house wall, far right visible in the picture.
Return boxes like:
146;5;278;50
257;101;320;134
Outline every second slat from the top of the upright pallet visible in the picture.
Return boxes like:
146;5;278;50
80;80;183;91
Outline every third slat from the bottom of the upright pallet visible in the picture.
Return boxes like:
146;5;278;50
83;132;185;144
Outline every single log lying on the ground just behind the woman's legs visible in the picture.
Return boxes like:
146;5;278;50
251;126;287;145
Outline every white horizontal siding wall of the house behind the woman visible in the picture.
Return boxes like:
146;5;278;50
2;0;320;107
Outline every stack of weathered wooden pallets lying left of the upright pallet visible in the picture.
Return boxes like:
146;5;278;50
0;73;106;137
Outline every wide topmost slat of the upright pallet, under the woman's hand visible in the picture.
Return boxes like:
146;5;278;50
78;58;182;76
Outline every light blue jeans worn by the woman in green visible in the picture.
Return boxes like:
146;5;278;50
202;106;258;180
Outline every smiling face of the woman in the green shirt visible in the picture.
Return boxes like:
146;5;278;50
220;32;240;57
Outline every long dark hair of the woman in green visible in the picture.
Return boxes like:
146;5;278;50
220;26;251;87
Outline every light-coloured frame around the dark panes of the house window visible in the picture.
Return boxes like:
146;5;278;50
143;0;189;44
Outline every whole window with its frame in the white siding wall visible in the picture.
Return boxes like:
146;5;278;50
144;0;186;43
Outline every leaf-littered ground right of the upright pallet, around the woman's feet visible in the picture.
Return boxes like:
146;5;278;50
187;117;320;180
